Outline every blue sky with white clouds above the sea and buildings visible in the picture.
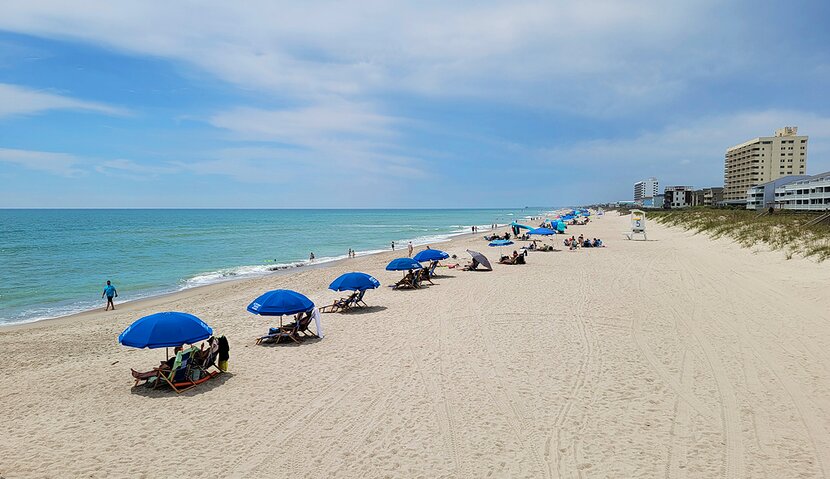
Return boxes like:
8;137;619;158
0;0;830;208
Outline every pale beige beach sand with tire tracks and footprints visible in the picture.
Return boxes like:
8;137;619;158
0;213;830;478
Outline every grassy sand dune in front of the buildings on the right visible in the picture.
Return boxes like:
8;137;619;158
648;208;830;262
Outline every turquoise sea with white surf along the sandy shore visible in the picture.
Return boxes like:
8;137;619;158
0;209;543;323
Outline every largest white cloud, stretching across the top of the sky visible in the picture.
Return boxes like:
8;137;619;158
0;0;752;115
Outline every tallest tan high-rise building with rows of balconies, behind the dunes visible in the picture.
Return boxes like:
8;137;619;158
723;126;807;202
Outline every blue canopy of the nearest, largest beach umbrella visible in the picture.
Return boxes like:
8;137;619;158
118;311;213;349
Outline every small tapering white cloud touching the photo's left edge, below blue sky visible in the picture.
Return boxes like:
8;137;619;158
0;83;126;118
